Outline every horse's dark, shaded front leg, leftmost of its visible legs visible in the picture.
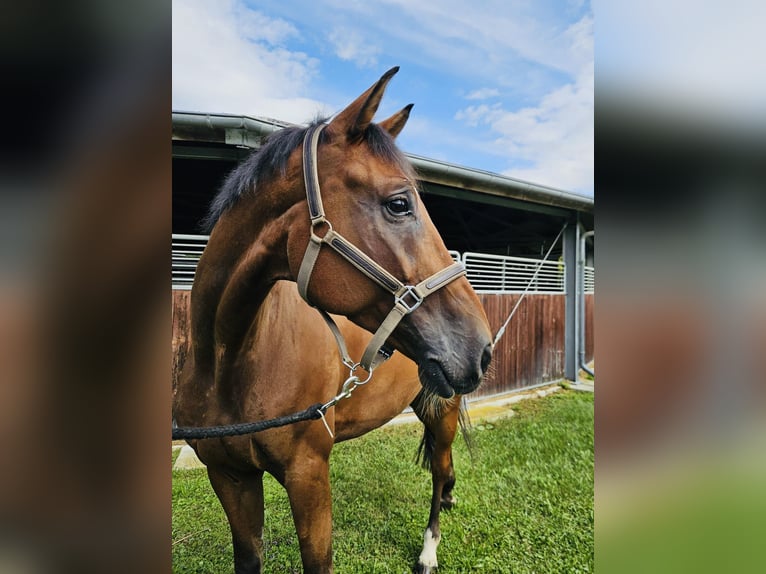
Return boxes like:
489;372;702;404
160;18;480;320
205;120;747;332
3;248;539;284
207;467;263;574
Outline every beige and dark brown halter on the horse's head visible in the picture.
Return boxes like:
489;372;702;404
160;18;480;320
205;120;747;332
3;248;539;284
297;124;465;375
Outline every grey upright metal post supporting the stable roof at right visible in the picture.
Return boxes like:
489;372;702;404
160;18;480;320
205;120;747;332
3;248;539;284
564;215;580;381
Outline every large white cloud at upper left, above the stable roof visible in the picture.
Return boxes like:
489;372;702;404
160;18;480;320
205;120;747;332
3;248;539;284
173;0;329;123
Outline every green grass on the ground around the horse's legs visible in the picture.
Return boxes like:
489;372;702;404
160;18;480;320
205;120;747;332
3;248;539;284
172;391;593;574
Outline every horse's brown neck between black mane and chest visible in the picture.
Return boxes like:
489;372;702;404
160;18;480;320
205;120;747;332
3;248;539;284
191;184;307;371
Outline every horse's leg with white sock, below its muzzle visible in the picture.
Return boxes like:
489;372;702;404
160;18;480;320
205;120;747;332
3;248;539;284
415;397;460;574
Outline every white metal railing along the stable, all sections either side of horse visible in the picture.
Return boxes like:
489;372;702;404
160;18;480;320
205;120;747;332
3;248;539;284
173;233;595;293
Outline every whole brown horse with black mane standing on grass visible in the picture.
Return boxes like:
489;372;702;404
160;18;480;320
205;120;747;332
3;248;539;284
174;68;491;573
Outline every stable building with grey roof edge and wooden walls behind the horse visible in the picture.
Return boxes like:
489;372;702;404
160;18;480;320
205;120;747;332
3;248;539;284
172;112;594;399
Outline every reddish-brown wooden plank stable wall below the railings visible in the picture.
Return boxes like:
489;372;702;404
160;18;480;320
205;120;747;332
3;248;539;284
172;290;594;397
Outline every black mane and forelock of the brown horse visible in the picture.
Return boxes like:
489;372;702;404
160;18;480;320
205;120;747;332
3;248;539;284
201;119;414;233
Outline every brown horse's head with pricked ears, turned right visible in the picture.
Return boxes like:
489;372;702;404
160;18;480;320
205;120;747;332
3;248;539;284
287;68;491;397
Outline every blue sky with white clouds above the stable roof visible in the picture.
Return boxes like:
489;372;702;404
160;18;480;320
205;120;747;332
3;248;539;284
172;0;594;196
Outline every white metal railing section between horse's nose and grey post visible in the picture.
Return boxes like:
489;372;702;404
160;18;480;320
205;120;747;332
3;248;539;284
463;252;564;293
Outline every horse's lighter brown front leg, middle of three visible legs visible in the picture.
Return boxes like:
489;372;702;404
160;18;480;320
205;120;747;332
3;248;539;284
284;454;333;574
